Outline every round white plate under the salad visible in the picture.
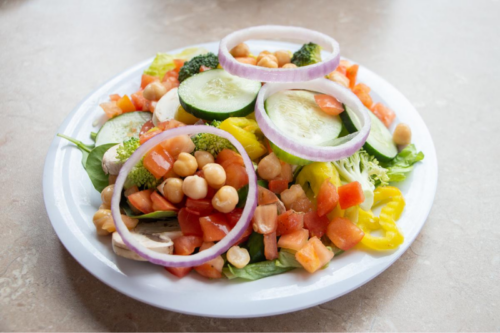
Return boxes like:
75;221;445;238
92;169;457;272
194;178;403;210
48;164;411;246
43;41;437;318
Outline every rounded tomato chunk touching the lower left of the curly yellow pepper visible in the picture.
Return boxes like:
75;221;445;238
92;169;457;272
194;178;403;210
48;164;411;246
326;217;365;251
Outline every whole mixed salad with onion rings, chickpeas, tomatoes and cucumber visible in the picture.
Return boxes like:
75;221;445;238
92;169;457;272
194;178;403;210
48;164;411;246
58;26;424;280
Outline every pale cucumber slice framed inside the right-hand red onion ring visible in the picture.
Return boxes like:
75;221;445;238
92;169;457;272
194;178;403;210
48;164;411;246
265;90;342;146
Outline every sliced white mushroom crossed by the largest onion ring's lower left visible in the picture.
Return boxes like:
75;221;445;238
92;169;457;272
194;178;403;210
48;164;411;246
112;221;182;261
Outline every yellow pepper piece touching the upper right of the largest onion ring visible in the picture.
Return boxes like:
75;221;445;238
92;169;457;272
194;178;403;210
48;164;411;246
219;117;267;160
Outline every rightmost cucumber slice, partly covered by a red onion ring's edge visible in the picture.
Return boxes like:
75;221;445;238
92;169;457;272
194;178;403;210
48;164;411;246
340;105;398;162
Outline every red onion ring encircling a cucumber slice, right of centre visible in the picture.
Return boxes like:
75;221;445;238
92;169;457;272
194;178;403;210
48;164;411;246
255;79;371;162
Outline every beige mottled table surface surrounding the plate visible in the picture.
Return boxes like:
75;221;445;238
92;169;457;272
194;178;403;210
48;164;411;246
0;0;500;331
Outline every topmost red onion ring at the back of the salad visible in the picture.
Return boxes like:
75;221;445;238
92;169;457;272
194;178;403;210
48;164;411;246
219;25;340;82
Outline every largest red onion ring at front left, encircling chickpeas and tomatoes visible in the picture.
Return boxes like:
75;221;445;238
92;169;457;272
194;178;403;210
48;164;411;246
111;125;257;267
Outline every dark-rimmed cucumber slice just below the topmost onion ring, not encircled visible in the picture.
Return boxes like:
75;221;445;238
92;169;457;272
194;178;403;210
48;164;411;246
179;69;261;120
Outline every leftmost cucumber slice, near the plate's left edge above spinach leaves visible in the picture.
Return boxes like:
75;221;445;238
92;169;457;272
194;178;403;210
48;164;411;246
95;111;151;146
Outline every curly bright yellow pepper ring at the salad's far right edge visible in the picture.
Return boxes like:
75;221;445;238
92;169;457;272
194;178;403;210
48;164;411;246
358;186;405;251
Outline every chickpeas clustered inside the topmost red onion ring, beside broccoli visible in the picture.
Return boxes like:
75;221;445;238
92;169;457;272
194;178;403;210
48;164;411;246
230;43;297;68
